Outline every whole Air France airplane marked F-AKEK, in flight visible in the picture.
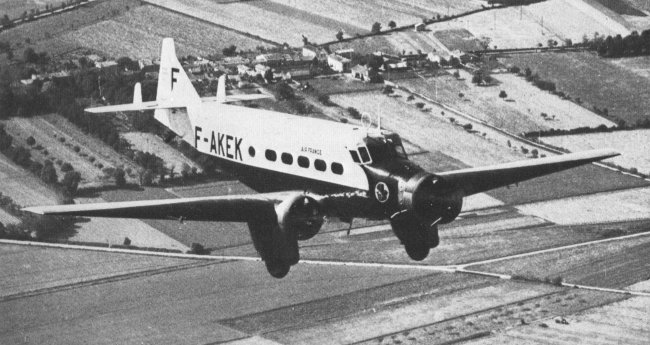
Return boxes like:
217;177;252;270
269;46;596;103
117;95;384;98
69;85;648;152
25;38;619;278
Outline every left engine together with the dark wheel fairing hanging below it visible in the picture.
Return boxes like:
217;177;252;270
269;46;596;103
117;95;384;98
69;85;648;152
248;194;324;278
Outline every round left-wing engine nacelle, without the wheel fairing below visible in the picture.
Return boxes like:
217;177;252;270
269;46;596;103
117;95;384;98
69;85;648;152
275;194;325;241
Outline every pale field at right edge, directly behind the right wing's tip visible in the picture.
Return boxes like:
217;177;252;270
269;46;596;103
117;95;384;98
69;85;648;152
542;129;650;175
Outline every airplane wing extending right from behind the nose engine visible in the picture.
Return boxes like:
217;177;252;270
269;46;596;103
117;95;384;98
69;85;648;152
437;150;620;196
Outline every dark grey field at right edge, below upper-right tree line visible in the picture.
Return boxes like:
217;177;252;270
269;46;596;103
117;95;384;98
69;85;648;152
503;53;650;124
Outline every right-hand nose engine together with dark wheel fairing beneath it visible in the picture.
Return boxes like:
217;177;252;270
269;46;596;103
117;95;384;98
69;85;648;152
390;172;463;261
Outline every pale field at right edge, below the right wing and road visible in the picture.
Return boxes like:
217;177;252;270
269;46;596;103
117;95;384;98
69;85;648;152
517;187;650;225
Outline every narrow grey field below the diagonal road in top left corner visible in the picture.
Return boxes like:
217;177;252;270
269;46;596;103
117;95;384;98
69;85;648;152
0;0;140;56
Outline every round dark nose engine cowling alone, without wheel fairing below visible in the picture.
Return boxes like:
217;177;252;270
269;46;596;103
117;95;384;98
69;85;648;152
399;173;463;224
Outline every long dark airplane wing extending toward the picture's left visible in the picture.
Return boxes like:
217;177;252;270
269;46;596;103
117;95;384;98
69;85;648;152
23;194;278;222
